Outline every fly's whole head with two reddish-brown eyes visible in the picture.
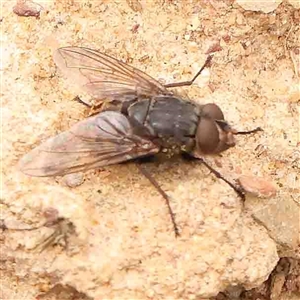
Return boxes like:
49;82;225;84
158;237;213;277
196;103;235;155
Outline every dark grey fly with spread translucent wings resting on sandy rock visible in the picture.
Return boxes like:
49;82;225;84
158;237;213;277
19;47;261;235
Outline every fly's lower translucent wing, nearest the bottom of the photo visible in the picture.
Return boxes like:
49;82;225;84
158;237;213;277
19;111;159;176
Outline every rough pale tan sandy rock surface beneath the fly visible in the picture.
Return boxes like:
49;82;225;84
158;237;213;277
0;0;300;299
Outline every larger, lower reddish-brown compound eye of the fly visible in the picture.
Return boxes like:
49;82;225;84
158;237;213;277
196;118;220;154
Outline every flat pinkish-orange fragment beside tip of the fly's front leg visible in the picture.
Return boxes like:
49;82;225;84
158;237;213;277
238;175;276;198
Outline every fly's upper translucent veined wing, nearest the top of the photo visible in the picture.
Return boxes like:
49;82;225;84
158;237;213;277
53;47;170;105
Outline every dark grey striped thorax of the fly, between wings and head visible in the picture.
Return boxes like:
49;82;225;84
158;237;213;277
128;96;199;141
